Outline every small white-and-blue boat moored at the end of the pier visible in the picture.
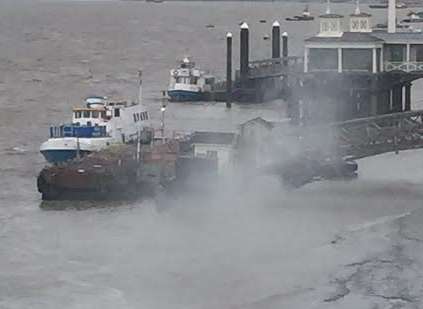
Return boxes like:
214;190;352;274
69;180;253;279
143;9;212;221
167;57;215;102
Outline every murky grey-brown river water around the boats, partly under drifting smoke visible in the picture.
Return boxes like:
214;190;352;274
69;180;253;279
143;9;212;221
0;0;423;309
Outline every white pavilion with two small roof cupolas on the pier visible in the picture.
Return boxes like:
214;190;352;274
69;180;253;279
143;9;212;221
304;4;423;74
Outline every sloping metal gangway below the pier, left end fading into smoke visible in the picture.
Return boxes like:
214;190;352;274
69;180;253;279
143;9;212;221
294;110;423;159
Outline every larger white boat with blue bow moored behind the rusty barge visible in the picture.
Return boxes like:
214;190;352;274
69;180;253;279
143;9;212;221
40;72;149;164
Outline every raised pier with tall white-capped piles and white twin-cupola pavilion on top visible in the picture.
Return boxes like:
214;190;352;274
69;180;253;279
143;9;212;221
220;0;423;124
